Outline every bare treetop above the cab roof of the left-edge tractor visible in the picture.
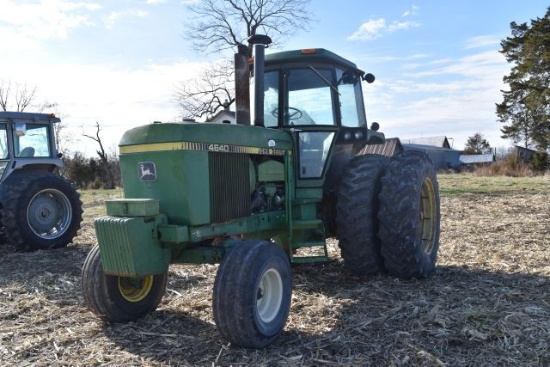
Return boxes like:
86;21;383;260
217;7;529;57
0;80;57;112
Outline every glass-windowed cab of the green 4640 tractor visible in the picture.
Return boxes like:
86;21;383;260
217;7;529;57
263;49;384;181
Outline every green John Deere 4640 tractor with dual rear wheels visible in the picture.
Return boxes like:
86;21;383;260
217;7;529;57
82;36;440;348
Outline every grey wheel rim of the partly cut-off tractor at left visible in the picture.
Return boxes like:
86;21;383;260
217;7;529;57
27;189;73;239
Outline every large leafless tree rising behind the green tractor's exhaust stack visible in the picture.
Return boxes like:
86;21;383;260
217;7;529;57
176;0;311;117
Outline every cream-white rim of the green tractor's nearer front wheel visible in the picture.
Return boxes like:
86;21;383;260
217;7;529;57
256;269;283;323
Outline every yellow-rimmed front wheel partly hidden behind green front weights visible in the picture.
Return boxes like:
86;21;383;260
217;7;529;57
81;245;168;322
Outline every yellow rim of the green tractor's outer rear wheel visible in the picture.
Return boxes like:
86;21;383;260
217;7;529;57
420;178;437;254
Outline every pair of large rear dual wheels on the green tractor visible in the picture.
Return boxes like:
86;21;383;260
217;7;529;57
337;151;440;279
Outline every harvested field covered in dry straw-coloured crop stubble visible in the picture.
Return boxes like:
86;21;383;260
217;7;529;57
0;174;550;366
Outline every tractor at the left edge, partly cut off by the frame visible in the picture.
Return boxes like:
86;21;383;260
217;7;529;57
0;112;82;251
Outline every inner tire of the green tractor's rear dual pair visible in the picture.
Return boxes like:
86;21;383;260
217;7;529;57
336;154;390;275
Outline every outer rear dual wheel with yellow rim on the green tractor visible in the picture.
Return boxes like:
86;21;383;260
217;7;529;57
378;151;440;279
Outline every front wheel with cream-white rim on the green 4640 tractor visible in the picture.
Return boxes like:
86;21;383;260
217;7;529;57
212;240;292;348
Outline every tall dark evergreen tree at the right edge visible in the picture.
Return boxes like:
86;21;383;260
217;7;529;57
496;7;550;150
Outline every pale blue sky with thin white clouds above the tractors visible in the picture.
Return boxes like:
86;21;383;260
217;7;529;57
0;0;549;156
